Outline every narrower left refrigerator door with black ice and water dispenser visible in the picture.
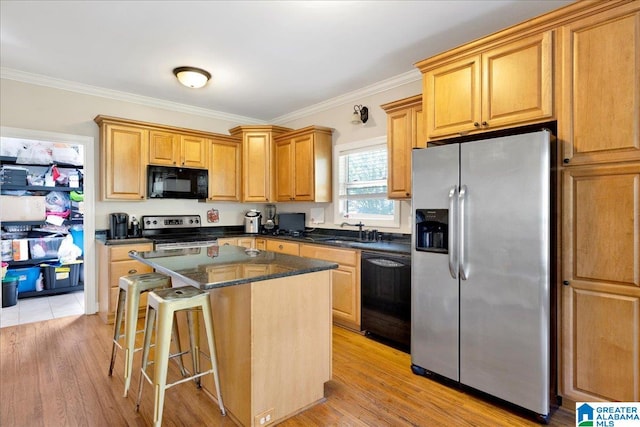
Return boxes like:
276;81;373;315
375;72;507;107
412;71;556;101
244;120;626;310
411;144;459;381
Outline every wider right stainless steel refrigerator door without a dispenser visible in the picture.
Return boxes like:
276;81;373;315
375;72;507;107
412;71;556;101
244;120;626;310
458;131;550;414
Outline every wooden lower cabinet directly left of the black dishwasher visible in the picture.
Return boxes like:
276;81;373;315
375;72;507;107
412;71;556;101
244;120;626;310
300;245;361;331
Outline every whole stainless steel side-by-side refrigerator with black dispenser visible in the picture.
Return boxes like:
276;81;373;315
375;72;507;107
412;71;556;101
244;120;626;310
411;130;552;418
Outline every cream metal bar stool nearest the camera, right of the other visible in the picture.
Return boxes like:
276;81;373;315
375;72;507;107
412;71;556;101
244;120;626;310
136;286;226;426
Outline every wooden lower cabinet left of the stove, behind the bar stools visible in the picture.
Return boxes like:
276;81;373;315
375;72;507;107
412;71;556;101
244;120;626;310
96;243;153;323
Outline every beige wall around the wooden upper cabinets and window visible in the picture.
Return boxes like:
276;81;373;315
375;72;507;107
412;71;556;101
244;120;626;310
0;75;421;233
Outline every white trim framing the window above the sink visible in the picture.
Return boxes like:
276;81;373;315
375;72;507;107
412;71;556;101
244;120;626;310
333;136;400;228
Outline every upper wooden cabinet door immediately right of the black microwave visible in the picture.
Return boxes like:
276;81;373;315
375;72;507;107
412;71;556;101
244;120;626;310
209;140;242;202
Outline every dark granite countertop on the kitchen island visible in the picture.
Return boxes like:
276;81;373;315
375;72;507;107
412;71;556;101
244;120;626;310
129;246;338;290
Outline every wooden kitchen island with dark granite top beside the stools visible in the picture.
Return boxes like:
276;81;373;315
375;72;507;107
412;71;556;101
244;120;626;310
129;246;337;426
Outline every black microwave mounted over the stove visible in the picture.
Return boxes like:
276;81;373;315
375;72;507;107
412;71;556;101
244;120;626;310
147;166;209;199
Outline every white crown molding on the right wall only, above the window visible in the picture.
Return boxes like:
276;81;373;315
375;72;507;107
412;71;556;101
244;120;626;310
271;69;422;125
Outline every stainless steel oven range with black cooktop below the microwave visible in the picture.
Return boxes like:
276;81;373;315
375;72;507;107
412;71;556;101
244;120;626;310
142;215;218;249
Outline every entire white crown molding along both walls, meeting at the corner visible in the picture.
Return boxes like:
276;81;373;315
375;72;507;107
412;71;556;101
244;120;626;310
0;67;422;125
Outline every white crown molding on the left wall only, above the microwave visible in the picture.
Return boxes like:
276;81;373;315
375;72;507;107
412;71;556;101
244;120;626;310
0;67;267;124
